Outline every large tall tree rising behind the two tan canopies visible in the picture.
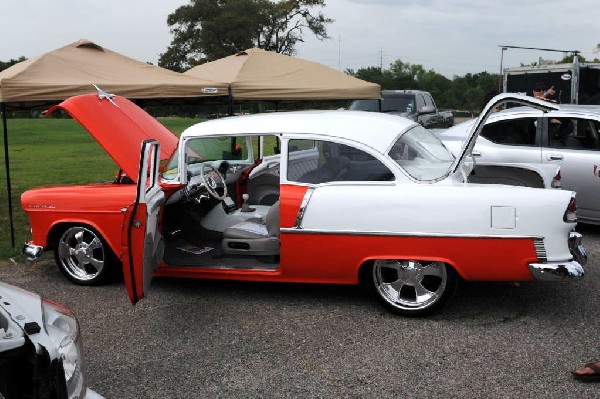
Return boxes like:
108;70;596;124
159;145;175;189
158;0;333;72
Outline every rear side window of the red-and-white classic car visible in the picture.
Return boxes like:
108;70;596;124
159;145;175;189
287;140;394;184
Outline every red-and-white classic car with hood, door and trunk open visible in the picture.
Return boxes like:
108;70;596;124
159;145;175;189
21;92;586;315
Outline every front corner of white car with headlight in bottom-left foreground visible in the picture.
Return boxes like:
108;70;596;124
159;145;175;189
0;283;102;399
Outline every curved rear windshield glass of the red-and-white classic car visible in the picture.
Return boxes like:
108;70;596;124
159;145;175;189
389;125;454;181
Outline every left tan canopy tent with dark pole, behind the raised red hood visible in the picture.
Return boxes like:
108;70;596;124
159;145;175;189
0;39;228;247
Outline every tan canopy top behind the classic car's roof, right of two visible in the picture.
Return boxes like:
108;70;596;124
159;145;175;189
184;48;381;100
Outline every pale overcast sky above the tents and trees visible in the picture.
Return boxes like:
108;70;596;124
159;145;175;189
0;0;600;78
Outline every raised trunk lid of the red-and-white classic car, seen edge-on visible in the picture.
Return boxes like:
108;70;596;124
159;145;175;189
450;93;560;177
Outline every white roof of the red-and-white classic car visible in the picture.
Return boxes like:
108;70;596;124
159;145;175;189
181;110;417;153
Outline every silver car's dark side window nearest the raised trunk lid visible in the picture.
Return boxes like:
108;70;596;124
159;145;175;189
481;118;537;146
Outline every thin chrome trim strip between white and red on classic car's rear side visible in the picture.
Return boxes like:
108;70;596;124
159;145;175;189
281;227;543;240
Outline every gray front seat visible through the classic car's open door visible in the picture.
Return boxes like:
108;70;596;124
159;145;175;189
222;201;279;255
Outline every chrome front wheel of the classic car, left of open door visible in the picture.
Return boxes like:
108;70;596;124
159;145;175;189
58;227;105;281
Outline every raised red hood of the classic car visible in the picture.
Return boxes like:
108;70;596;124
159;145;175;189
45;90;179;180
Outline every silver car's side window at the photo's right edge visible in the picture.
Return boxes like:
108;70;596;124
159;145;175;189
548;118;600;150
